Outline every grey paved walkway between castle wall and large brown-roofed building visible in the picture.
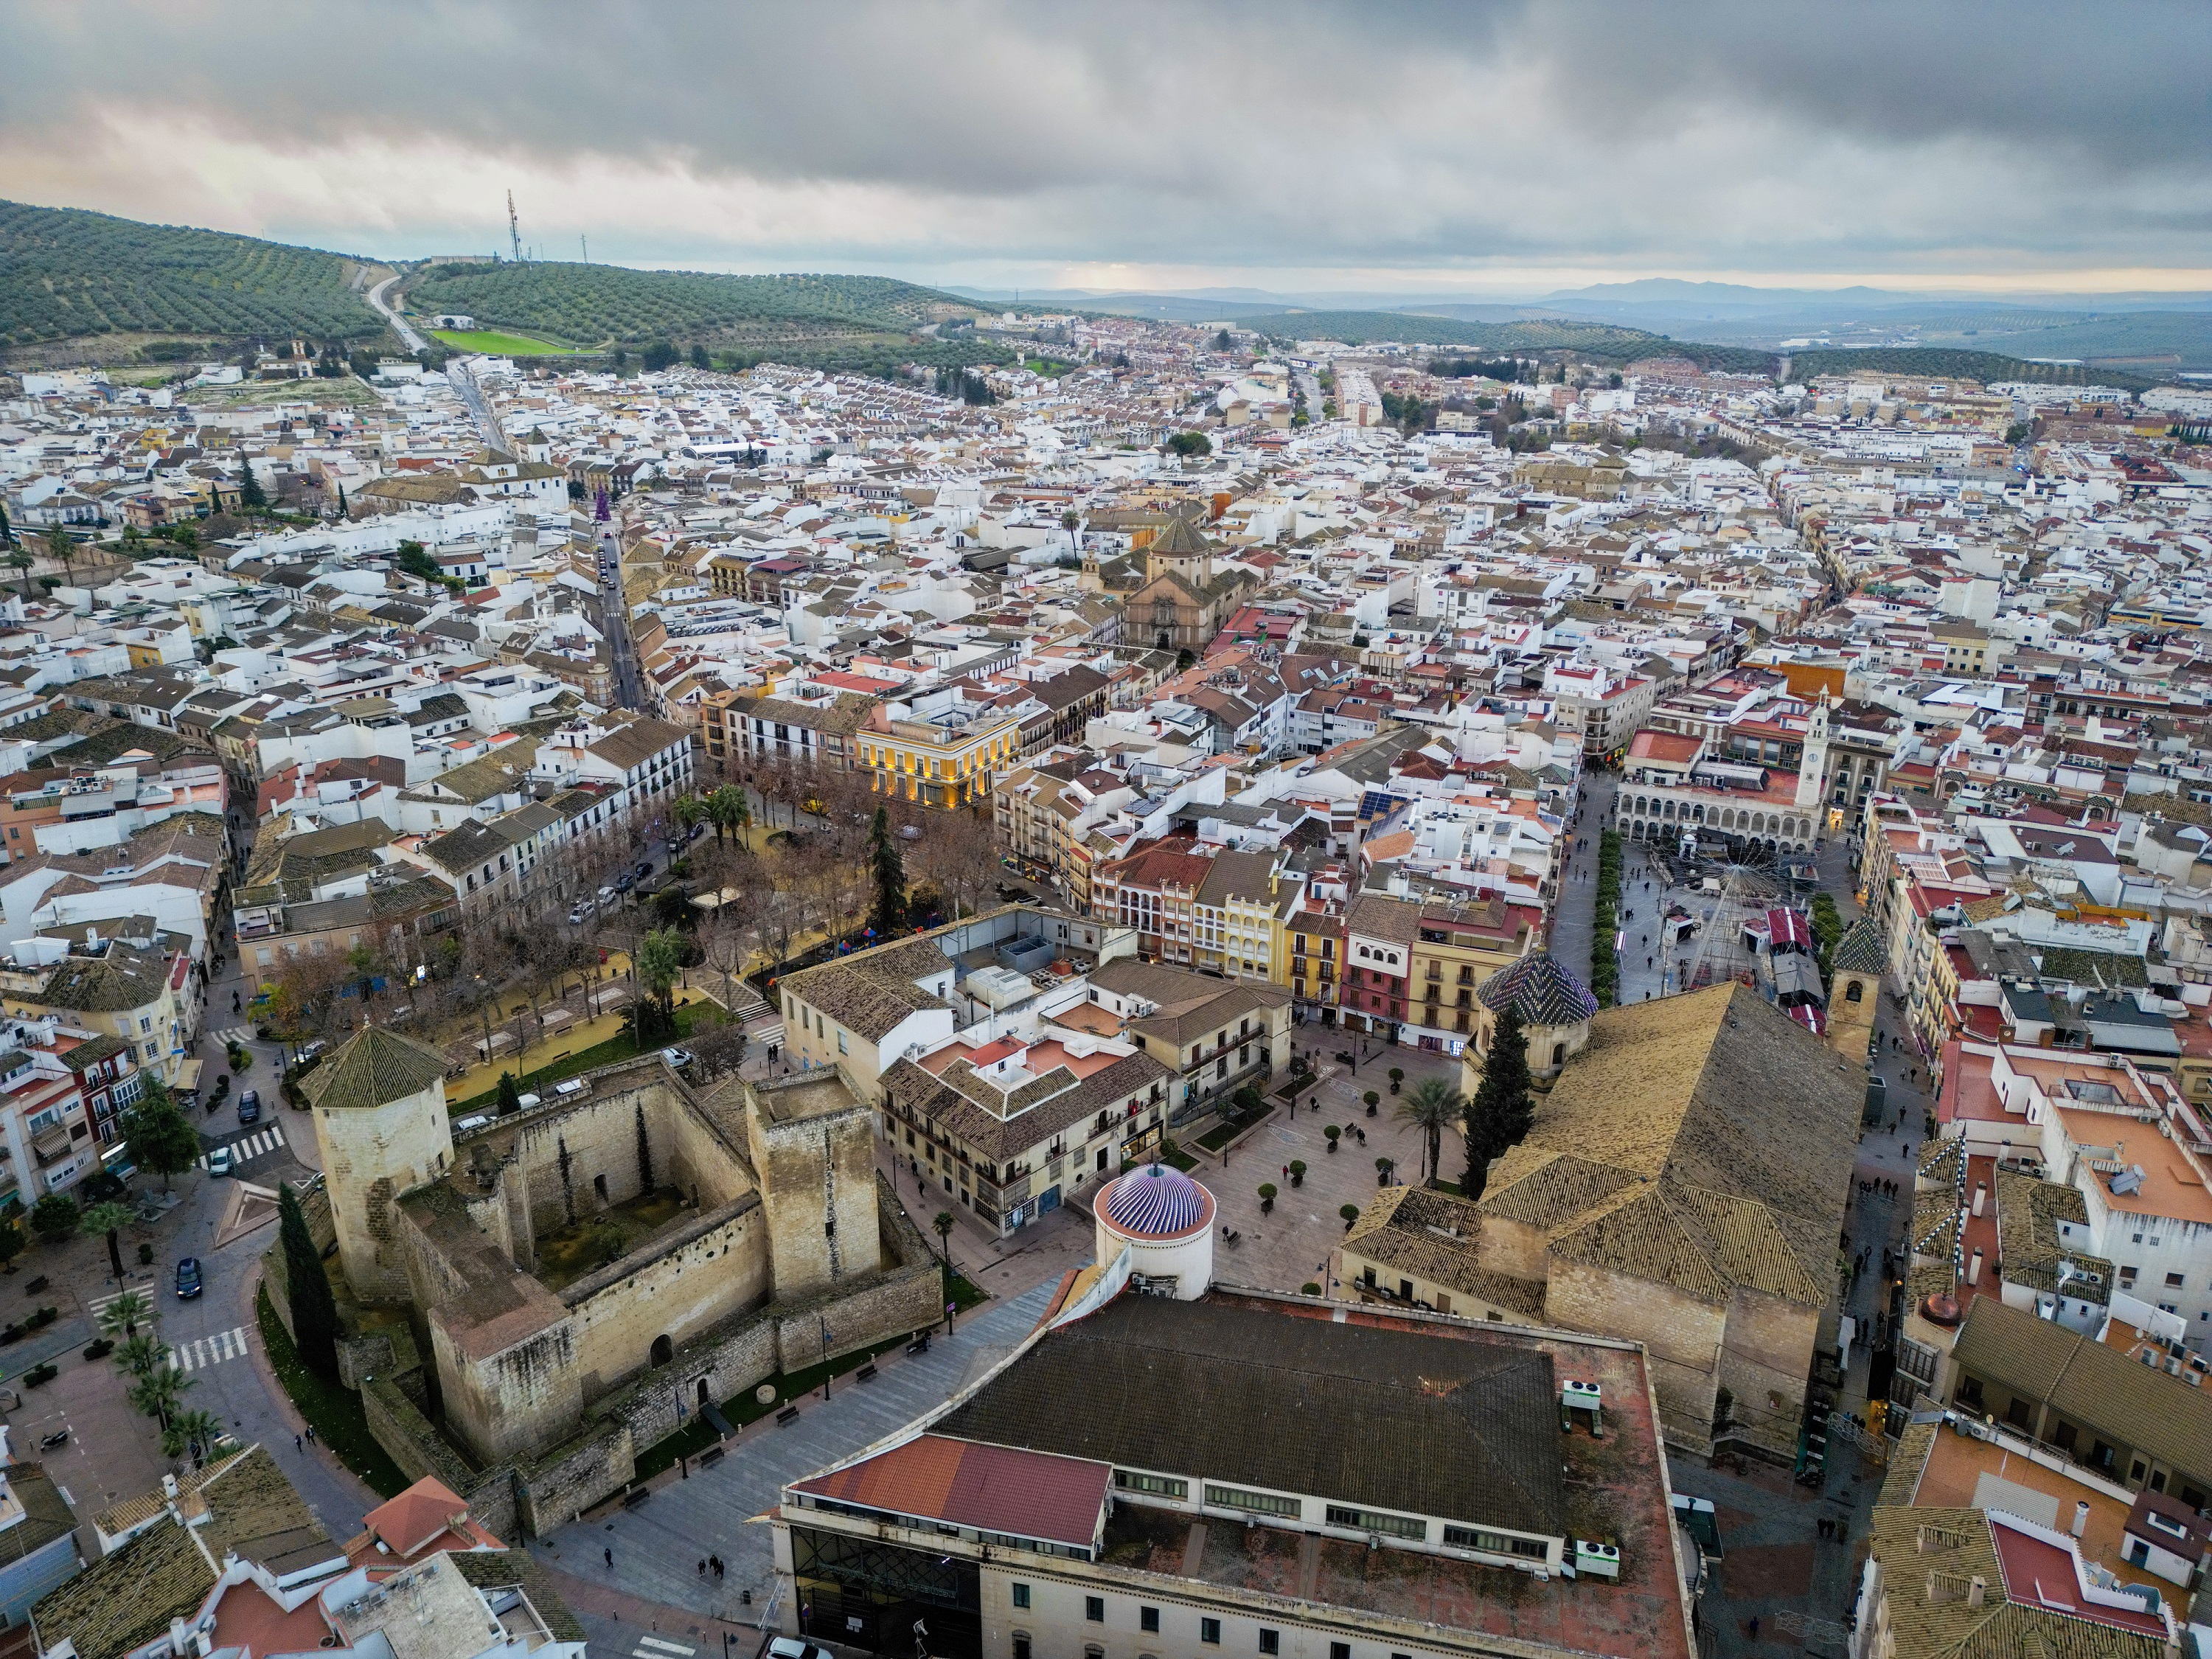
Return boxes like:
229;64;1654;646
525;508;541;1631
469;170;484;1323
531;1285;1053;1659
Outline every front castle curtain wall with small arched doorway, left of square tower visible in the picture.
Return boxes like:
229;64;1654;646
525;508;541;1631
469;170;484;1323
562;1194;768;1407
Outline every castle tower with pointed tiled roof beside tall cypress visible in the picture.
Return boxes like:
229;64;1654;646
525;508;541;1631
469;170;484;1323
301;1026;453;1303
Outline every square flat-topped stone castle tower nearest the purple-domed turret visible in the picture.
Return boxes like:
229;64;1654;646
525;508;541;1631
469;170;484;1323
745;1066;883;1310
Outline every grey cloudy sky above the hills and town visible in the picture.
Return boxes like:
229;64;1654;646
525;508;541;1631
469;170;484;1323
0;0;2212;294
